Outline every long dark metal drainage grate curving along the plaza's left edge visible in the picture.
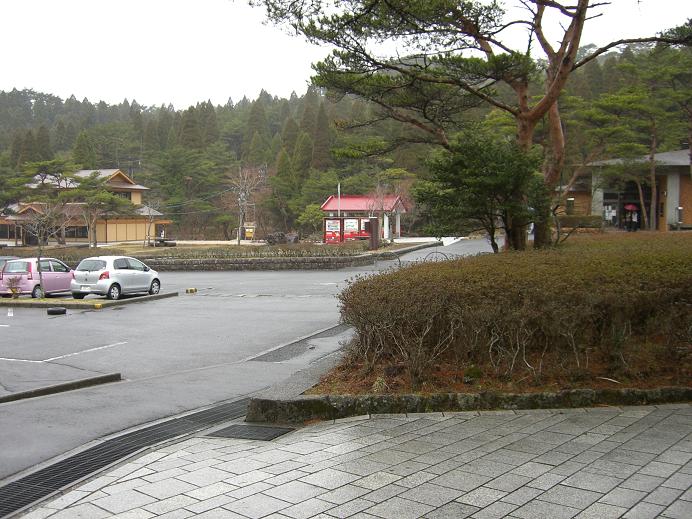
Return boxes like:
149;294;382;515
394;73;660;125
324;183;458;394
0;398;249;518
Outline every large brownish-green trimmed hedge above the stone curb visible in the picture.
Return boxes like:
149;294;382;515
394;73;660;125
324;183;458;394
339;233;692;388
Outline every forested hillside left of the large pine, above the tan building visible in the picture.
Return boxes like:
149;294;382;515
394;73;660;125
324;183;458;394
0;88;436;239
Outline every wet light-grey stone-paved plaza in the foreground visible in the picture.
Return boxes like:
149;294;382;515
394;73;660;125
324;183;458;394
24;404;692;519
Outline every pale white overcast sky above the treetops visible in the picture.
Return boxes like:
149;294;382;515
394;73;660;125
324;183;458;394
0;0;692;108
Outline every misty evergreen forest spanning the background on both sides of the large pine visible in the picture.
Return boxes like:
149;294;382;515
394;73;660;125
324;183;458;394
0;44;692;239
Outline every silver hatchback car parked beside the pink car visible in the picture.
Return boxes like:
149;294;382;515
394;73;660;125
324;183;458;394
70;256;161;299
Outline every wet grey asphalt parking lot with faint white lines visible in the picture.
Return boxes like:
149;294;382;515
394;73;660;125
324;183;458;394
0;240;498;482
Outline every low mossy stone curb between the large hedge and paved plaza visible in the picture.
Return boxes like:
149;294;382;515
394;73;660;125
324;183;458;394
245;387;692;424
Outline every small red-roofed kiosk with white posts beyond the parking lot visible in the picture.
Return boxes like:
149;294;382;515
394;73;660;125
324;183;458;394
321;195;406;243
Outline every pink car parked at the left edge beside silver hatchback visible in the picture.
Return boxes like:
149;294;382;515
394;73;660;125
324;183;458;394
0;258;74;297
